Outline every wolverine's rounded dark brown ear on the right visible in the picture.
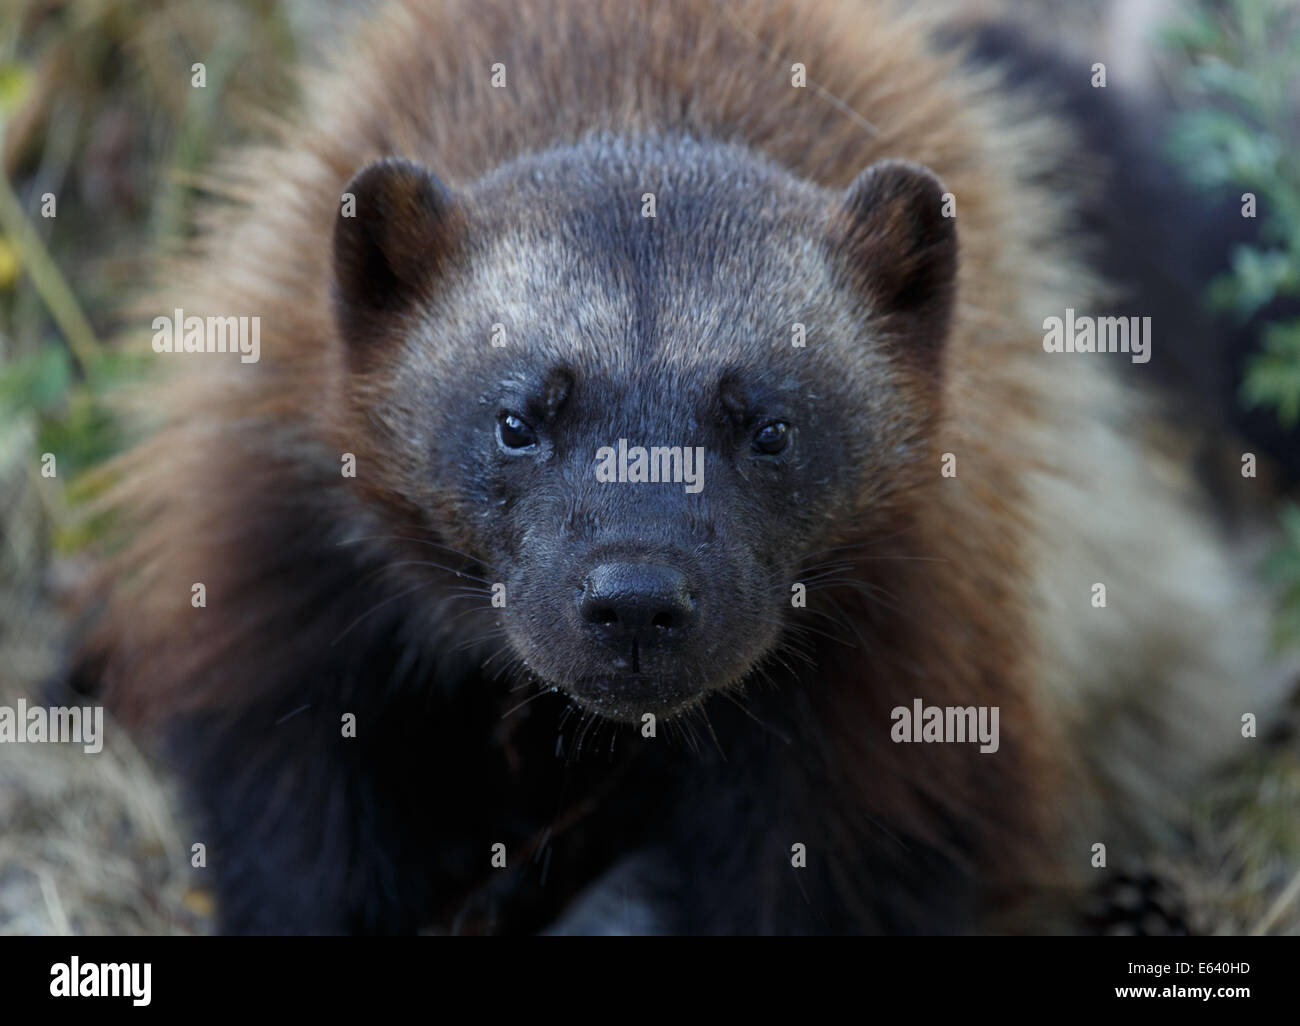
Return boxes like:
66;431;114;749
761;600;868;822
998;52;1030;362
835;160;957;356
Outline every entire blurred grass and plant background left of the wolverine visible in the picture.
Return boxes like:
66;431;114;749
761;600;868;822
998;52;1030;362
0;0;314;935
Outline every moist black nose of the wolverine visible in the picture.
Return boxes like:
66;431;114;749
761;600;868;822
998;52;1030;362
577;563;696;644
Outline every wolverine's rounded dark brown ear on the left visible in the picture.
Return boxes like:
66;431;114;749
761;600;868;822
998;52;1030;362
333;157;460;345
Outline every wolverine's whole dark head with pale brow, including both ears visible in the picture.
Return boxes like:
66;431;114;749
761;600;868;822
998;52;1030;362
335;131;954;722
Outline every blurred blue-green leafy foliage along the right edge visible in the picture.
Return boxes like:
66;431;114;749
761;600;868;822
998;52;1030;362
1166;0;1300;644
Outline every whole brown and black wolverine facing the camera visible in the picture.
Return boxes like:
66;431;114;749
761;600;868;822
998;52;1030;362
77;0;1284;934
